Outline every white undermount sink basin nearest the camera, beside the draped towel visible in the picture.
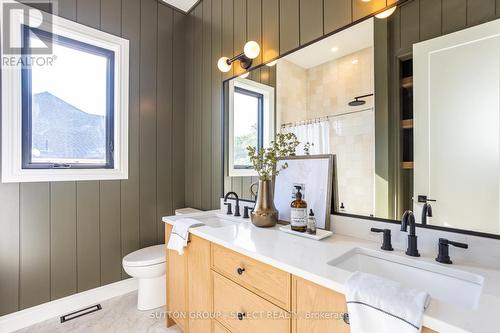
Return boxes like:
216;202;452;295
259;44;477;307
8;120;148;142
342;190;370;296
328;248;484;309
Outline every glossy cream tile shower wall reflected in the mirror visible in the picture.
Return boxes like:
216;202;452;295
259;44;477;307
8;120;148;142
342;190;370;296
277;48;375;216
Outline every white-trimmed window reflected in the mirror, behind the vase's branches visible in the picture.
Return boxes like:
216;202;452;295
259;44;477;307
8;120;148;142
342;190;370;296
229;78;274;177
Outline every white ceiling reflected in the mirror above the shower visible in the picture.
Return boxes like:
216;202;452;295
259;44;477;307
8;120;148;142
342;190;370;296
282;18;373;69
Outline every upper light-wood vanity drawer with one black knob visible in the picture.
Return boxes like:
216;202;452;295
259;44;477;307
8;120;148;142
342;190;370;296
212;244;291;311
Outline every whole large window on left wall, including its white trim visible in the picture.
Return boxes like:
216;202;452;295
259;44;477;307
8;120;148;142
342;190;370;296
2;3;129;182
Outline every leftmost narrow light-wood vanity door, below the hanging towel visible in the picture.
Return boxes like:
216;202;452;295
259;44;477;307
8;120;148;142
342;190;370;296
165;224;189;332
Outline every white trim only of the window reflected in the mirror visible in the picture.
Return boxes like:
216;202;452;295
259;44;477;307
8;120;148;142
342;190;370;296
228;78;275;177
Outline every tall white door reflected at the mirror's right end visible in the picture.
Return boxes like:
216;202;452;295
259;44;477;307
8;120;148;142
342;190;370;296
413;20;500;234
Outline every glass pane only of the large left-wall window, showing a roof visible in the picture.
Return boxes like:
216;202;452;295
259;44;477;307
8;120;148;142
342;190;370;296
25;31;110;165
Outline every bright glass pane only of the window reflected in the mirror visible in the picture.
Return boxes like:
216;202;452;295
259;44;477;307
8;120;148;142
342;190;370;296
234;91;259;168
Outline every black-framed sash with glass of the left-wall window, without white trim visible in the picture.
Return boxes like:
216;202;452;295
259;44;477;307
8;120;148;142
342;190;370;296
21;26;114;169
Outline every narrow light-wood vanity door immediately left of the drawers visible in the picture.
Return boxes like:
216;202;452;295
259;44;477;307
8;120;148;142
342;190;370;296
188;235;213;333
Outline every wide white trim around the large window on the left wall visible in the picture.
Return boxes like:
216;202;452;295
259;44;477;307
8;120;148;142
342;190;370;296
0;0;129;183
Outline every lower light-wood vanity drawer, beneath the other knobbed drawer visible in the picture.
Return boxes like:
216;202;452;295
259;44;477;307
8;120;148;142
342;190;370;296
212;272;291;333
